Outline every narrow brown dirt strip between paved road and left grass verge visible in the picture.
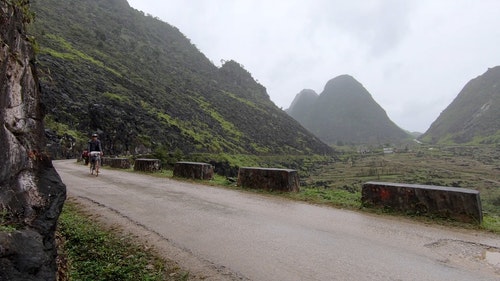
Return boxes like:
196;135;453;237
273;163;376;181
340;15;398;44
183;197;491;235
67;194;249;281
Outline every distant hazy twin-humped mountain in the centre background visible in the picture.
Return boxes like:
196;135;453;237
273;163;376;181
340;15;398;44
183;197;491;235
287;75;410;144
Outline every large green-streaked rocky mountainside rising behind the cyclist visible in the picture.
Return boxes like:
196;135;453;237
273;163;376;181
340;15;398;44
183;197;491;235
31;0;332;155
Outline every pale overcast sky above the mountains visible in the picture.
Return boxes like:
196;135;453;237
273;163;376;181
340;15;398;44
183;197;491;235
128;0;500;132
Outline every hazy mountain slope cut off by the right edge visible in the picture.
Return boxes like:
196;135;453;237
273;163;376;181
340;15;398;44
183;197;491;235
420;66;500;144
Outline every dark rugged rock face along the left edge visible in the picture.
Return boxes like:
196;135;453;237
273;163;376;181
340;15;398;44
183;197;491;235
0;1;66;280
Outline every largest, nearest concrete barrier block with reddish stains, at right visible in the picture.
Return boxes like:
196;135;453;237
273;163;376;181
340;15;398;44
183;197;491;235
361;182;483;224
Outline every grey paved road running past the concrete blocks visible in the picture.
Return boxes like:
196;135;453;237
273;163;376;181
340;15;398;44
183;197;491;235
54;160;500;280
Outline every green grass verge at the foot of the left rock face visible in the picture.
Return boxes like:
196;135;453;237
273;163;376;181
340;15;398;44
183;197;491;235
58;200;189;281
